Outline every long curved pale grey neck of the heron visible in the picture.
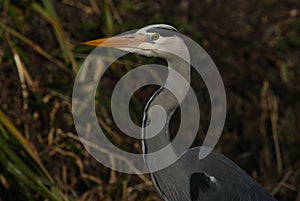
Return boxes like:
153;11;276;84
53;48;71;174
142;55;190;154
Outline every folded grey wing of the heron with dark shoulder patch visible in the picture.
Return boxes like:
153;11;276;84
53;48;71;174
181;147;276;201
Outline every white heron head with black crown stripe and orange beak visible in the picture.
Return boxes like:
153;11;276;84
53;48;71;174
83;24;184;58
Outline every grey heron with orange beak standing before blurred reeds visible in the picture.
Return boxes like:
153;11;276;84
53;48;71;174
84;24;276;201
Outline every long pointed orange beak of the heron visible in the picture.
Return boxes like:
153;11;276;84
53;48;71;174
82;33;147;48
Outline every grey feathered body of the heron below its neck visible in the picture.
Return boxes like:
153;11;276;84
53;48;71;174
143;147;276;201
